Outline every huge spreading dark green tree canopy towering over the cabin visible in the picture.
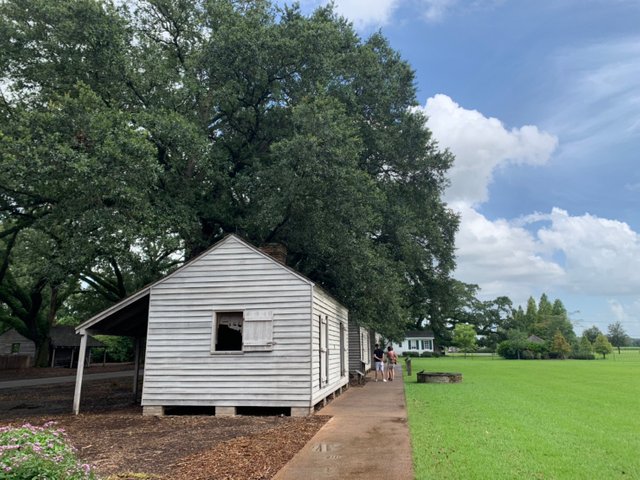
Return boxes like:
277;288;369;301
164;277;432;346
0;0;458;354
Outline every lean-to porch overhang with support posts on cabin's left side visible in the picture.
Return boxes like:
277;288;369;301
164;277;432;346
73;287;151;415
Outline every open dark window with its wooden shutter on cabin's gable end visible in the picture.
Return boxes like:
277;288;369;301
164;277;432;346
212;310;274;352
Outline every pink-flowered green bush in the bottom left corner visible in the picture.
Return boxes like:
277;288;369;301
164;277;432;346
0;422;96;480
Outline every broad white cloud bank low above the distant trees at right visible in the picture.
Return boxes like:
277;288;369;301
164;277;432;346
452;203;640;308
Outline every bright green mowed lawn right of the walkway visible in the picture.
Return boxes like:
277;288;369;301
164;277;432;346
405;350;640;480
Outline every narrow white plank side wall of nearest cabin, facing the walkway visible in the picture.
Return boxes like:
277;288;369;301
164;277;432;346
311;287;349;404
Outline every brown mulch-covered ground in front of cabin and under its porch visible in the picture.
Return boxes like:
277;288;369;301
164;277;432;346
0;367;329;480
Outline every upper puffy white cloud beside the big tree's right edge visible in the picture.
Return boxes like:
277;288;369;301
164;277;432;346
424;94;558;205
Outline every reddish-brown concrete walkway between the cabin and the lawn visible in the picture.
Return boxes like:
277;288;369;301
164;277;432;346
273;366;414;480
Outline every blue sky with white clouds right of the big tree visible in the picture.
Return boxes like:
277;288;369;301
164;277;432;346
284;0;640;338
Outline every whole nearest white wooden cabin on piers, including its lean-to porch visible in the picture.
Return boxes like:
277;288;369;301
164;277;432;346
74;235;349;416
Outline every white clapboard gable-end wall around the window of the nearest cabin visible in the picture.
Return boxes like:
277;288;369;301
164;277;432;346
142;237;312;407
